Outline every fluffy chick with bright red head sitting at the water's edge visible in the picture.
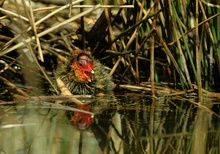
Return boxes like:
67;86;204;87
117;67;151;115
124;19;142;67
55;49;114;95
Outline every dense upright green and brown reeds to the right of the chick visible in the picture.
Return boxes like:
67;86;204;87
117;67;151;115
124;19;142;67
93;0;220;98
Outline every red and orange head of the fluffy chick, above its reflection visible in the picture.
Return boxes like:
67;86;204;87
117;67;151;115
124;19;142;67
70;52;94;83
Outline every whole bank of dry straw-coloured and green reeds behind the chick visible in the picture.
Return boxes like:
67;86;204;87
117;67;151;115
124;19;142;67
0;0;220;102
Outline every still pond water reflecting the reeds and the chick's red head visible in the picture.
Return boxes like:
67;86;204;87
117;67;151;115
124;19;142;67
0;93;220;154
